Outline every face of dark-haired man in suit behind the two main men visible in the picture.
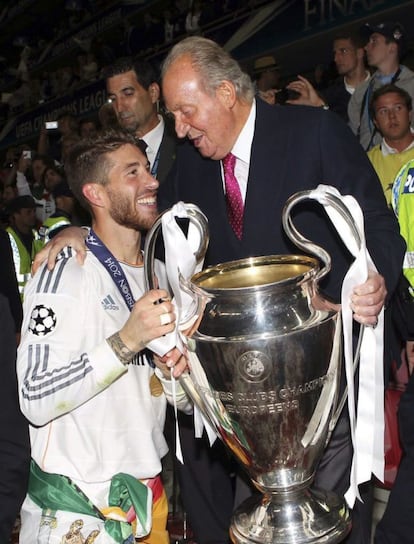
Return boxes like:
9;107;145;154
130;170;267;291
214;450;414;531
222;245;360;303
106;70;160;136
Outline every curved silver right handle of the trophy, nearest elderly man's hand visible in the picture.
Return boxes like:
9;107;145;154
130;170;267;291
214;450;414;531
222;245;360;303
282;190;361;281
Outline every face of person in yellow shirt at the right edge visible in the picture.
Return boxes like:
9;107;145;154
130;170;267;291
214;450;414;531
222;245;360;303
374;93;411;143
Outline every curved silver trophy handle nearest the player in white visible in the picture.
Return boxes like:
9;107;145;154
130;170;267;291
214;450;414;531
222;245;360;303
144;203;209;321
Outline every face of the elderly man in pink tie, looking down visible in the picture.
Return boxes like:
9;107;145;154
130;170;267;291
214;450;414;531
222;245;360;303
163;56;238;160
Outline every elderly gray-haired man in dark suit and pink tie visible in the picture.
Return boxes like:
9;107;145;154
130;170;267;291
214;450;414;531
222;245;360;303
159;37;404;544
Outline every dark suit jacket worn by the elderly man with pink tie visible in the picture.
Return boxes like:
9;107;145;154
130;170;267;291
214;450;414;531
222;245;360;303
159;100;404;300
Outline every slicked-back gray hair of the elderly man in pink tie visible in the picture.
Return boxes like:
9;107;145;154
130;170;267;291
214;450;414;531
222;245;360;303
161;36;255;103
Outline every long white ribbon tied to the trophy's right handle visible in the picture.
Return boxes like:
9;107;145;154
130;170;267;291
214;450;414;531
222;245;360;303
309;185;384;507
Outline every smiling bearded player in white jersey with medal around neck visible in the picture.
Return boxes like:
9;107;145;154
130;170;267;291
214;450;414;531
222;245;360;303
17;129;191;544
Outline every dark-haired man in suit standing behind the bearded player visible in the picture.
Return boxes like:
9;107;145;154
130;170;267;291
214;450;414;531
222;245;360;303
102;57;178;183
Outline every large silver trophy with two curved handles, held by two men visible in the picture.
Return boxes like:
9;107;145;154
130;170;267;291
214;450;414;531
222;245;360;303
145;192;353;544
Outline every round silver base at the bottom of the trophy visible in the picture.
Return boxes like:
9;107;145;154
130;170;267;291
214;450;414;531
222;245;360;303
230;489;351;544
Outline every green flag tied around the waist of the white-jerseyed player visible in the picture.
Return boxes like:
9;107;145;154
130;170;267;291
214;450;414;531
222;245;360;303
28;459;152;544
